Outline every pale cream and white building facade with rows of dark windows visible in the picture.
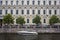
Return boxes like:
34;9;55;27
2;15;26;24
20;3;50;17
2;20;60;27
0;0;60;25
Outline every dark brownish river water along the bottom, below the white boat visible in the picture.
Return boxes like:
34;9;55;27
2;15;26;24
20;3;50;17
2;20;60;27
0;33;60;40
